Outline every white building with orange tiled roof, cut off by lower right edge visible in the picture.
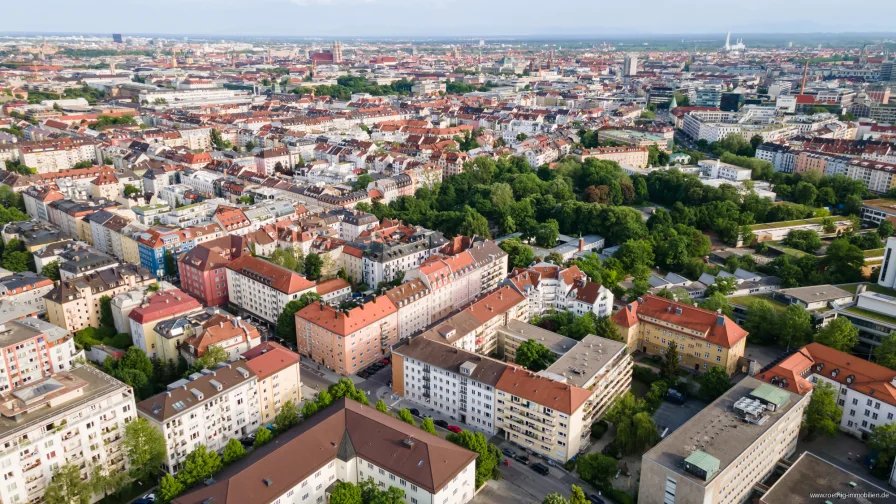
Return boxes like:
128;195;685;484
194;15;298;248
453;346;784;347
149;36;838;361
756;343;896;438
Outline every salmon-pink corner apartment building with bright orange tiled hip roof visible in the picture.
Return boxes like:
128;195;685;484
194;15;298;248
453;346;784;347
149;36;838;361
296;296;398;375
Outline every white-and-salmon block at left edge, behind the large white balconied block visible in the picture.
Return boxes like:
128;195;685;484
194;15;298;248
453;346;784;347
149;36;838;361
0;317;79;393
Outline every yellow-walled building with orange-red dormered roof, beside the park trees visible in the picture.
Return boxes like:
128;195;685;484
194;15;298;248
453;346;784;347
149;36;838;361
612;295;747;375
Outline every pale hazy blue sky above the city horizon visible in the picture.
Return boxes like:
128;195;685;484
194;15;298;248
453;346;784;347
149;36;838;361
0;0;896;37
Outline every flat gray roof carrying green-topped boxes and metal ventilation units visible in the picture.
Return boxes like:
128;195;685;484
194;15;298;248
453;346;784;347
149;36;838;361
644;376;808;486
